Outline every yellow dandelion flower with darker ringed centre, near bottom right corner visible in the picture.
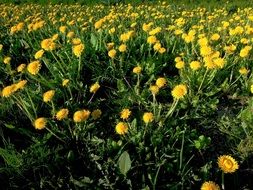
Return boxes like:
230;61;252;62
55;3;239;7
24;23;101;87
218;155;239;173
